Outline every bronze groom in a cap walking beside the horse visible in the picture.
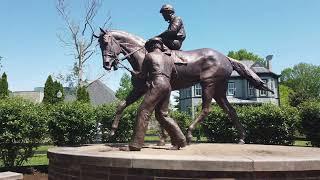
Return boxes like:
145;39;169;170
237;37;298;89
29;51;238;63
129;38;186;151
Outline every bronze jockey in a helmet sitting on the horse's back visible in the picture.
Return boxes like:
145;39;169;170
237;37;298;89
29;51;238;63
157;4;186;50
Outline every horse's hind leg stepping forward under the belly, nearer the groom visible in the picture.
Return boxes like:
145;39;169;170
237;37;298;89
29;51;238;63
186;85;214;144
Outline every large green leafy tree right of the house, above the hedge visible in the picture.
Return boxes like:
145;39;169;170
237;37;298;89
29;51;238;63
280;63;320;101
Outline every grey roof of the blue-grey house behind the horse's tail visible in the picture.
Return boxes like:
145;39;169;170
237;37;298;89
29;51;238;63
231;60;279;77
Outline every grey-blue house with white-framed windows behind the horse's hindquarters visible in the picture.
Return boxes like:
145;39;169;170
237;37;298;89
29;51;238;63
179;60;280;117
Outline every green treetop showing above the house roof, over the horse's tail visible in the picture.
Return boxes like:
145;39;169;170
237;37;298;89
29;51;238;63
228;49;265;64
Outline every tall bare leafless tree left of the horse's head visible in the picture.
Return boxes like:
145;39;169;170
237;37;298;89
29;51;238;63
56;0;111;85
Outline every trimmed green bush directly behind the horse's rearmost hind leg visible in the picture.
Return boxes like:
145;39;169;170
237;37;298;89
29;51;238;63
203;104;299;144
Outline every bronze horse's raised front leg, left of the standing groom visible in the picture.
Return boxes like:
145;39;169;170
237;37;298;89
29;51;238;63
110;88;146;136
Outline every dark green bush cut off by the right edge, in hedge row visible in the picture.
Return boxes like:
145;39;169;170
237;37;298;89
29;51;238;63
300;101;320;147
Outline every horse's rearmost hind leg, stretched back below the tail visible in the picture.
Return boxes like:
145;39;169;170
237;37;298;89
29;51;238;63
215;95;245;144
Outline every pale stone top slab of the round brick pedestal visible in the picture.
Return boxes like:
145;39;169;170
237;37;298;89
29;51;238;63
48;143;320;172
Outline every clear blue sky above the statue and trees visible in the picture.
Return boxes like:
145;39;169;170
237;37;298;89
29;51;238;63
0;0;320;91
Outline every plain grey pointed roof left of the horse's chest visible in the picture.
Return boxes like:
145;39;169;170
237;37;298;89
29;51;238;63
87;80;116;105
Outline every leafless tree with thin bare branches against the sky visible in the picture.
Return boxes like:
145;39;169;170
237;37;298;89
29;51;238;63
55;0;111;86
